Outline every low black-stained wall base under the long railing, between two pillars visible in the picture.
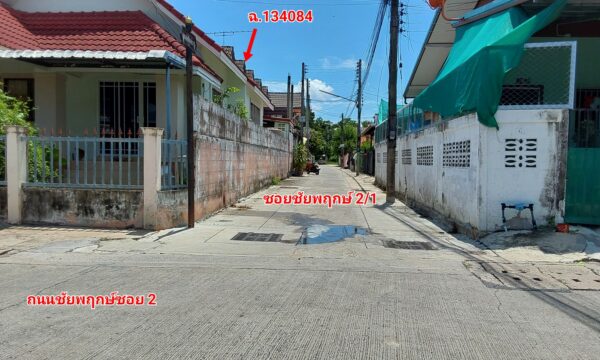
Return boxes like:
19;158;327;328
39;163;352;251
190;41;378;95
23;187;143;229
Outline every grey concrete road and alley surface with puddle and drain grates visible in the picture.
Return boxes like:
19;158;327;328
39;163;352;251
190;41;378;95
0;166;600;360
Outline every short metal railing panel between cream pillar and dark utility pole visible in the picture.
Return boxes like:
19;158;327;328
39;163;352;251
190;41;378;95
160;139;187;190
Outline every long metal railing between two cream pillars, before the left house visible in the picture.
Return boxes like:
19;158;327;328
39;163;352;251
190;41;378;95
26;136;144;189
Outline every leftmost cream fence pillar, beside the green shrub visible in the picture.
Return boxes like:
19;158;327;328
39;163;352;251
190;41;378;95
6;125;27;224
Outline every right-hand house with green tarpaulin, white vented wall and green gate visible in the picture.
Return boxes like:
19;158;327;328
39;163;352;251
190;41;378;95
375;0;600;237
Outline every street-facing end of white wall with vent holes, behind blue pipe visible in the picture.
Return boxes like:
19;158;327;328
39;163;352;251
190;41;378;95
481;110;569;230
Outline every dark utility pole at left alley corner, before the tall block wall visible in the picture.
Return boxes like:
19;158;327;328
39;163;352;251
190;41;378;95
182;17;196;229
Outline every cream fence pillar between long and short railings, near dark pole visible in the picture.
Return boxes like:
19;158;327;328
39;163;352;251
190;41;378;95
142;127;164;230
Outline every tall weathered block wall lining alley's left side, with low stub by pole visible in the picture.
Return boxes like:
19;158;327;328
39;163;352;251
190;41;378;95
158;97;293;228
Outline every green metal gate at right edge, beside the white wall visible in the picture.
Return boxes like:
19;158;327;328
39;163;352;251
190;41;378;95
565;107;600;225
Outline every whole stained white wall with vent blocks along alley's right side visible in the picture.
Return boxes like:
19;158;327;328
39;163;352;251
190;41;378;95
375;110;568;236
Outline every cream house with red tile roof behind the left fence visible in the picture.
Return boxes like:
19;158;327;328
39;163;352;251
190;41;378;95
0;0;272;138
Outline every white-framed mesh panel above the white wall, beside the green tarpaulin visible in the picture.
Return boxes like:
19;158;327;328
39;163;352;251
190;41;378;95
500;41;577;109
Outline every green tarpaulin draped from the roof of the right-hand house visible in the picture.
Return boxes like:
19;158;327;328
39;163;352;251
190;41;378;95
413;0;567;127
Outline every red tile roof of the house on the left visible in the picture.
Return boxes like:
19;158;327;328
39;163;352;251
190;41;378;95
0;3;222;80
